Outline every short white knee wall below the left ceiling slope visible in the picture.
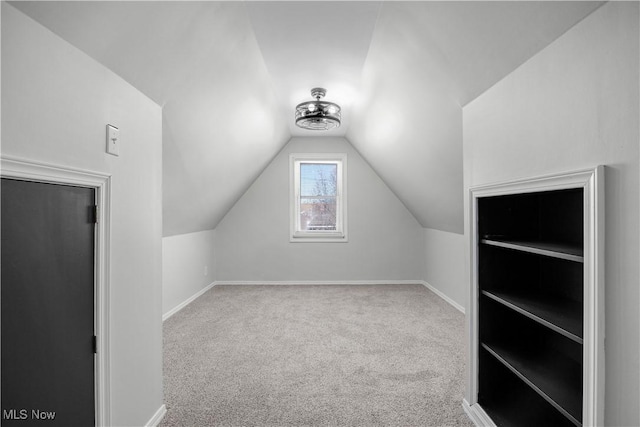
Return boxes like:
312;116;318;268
162;230;216;315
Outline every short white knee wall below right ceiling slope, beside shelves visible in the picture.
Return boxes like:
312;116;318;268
424;228;469;310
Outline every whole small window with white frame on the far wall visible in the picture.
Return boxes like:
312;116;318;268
290;154;347;242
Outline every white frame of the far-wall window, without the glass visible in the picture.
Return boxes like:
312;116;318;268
289;153;348;243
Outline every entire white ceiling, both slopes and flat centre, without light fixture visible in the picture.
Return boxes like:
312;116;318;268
11;1;603;236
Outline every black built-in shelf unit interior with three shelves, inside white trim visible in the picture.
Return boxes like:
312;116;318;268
477;188;585;426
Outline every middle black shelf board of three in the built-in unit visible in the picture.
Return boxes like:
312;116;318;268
482;290;583;344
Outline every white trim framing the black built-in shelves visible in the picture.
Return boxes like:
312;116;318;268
463;166;605;426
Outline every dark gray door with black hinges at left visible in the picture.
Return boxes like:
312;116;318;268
0;179;95;427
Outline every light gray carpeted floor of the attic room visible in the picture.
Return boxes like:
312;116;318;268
160;285;472;427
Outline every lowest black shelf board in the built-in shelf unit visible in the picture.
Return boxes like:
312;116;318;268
482;343;582;426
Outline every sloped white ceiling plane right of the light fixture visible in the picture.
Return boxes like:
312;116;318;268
346;1;600;233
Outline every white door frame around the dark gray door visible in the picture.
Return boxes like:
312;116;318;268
0;155;111;427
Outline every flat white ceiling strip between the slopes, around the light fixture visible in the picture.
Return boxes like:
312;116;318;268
246;1;382;136
